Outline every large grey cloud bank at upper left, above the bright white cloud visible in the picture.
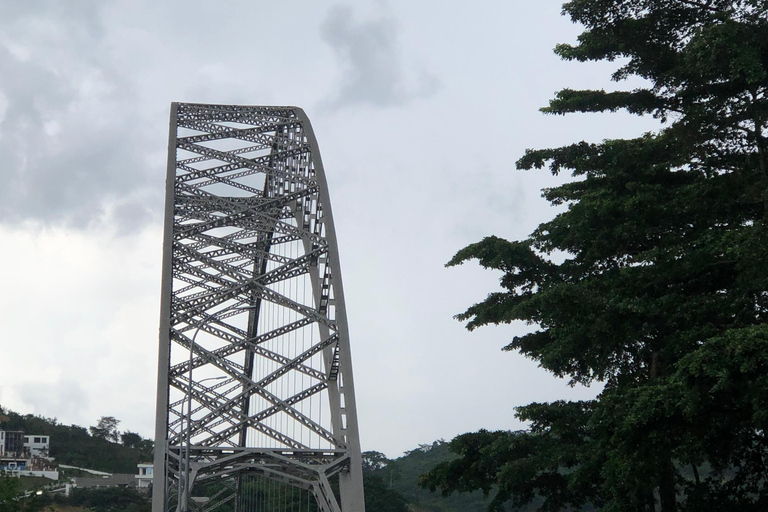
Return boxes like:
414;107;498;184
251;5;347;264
0;1;162;232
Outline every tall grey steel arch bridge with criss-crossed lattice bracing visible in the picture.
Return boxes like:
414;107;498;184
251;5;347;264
152;103;364;512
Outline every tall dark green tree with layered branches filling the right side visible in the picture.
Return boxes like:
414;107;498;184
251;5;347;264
422;0;768;512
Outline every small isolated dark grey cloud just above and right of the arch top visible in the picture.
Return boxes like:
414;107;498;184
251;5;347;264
320;5;439;108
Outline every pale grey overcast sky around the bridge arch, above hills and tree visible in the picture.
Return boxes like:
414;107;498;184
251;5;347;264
0;0;655;457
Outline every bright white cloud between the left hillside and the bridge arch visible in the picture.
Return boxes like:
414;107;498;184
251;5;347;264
0;225;162;436
